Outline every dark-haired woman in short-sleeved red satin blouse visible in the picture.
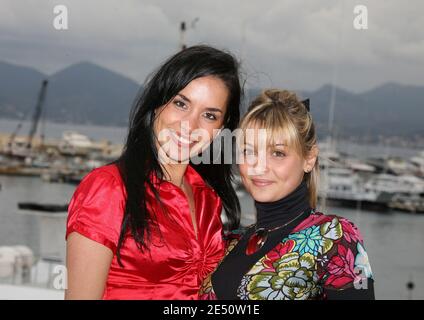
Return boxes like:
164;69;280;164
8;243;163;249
65;46;241;299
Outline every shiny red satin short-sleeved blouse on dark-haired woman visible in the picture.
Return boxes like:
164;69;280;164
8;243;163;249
66;165;224;299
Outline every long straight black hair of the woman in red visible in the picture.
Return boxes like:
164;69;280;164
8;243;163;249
113;45;242;267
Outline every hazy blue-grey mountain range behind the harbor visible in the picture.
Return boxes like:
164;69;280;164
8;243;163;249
0;62;424;137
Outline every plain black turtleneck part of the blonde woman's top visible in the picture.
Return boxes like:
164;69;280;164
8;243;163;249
211;181;374;300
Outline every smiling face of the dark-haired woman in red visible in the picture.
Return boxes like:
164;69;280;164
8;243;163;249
154;76;229;163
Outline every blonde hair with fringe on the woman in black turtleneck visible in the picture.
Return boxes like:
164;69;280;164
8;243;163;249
239;89;319;208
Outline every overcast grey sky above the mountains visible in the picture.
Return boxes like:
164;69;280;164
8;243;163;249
0;0;424;92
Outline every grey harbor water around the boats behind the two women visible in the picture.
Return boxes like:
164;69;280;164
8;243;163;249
0;120;424;299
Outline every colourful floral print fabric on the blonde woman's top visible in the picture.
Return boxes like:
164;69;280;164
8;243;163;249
200;211;373;300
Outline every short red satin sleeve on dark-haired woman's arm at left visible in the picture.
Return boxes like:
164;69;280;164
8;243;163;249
66;167;125;254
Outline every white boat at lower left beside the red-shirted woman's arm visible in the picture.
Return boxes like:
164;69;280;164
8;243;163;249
0;210;67;300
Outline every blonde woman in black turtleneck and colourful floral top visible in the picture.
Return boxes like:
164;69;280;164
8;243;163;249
201;90;374;300
